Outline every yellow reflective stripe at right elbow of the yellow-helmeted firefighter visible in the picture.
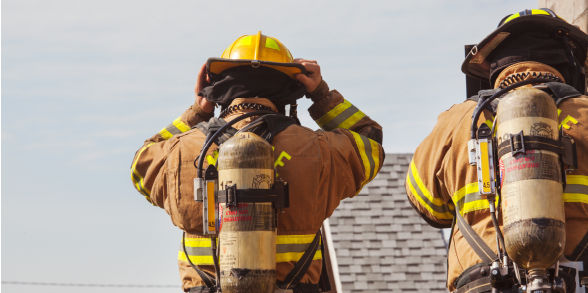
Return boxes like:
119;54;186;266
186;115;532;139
349;131;381;186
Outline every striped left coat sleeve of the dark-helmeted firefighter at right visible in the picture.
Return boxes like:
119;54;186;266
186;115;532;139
405;107;457;228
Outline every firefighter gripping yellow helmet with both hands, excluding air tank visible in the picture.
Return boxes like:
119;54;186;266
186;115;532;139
131;32;384;292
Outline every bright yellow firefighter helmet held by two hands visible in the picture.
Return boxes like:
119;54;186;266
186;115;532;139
206;31;306;78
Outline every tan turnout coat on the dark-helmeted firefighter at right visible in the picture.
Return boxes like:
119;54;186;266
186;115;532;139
406;64;588;290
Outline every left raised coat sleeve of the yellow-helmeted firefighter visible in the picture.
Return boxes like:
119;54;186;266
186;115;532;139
131;104;212;204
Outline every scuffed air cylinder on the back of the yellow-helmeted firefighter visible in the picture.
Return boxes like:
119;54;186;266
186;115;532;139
217;132;277;293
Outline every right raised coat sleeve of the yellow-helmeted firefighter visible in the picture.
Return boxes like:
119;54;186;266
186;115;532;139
309;81;385;215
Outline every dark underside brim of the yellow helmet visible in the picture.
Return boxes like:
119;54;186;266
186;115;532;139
206;58;306;79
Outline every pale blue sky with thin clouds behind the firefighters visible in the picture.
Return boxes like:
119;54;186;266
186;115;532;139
1;0;537;293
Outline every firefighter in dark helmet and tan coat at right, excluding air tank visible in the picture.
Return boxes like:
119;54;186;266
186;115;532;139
405;9;588;292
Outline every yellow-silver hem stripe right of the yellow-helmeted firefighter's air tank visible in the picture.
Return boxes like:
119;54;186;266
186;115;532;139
276;234;323;262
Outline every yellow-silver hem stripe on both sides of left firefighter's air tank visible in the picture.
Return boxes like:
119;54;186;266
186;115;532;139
178;234;322;265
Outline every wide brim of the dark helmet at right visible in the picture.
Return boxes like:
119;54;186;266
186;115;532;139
461;15;588;79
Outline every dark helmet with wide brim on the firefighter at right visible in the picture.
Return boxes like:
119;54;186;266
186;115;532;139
461;8;588;92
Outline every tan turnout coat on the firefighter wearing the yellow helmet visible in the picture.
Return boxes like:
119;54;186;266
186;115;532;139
131;82;384;290
